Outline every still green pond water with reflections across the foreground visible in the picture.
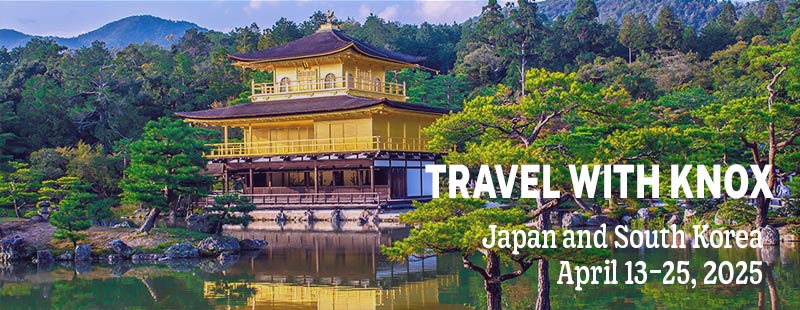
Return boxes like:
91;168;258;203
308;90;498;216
0;223;800;309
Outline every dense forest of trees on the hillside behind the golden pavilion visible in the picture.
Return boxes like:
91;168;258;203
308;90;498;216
0;0;800;220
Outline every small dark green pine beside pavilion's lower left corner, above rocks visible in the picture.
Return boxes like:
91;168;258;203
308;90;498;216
205;193;256;235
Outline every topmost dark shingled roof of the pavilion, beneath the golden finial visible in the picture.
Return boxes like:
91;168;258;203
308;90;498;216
228;30;425;64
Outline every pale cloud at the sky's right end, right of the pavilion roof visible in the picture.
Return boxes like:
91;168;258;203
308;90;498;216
416;0;483;23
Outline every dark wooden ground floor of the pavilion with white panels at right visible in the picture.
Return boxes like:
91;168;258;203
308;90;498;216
201;151;439;209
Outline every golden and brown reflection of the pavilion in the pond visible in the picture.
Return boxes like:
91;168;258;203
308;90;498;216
212;223;466;309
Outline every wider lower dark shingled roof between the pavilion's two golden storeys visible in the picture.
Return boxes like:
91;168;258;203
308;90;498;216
175;96;451;120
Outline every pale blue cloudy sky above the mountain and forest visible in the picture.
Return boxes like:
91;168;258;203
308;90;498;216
0;0;485;37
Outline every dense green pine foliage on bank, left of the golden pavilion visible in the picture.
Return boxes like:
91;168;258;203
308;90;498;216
122;118;212;211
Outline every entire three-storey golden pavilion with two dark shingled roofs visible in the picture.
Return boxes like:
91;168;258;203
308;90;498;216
178;15;449;208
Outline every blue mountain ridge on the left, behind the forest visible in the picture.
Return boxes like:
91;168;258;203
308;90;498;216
0;15;208;48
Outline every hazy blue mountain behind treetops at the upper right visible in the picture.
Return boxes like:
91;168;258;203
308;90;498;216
537;0;788;29
